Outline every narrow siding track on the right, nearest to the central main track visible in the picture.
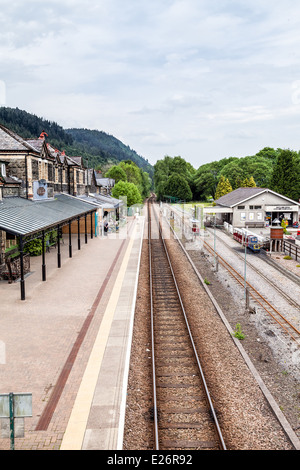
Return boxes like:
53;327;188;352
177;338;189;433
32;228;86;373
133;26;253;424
204;241;300;346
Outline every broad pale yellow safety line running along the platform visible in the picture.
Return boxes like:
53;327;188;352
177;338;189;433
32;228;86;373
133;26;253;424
60;225;136;450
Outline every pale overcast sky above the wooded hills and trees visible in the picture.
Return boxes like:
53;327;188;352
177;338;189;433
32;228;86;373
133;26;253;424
0;0;300;168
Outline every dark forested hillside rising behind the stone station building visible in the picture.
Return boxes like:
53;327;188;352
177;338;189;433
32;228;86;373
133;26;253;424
0;106;153;177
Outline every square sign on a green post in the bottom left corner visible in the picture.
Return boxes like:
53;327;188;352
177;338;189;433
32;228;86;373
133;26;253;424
0;393;32;450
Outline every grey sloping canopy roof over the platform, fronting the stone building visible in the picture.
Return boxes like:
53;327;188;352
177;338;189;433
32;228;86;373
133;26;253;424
0;194;98;235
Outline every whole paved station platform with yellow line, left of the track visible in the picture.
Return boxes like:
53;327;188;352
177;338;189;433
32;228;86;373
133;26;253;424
0;216;145;450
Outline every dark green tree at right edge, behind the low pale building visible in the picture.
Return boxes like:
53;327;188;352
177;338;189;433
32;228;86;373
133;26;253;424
270;149;300;201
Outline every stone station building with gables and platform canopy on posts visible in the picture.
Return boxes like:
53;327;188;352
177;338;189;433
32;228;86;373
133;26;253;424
0;124;121;300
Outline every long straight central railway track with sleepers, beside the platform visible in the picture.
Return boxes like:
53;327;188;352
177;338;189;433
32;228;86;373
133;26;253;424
148;201;226;450
